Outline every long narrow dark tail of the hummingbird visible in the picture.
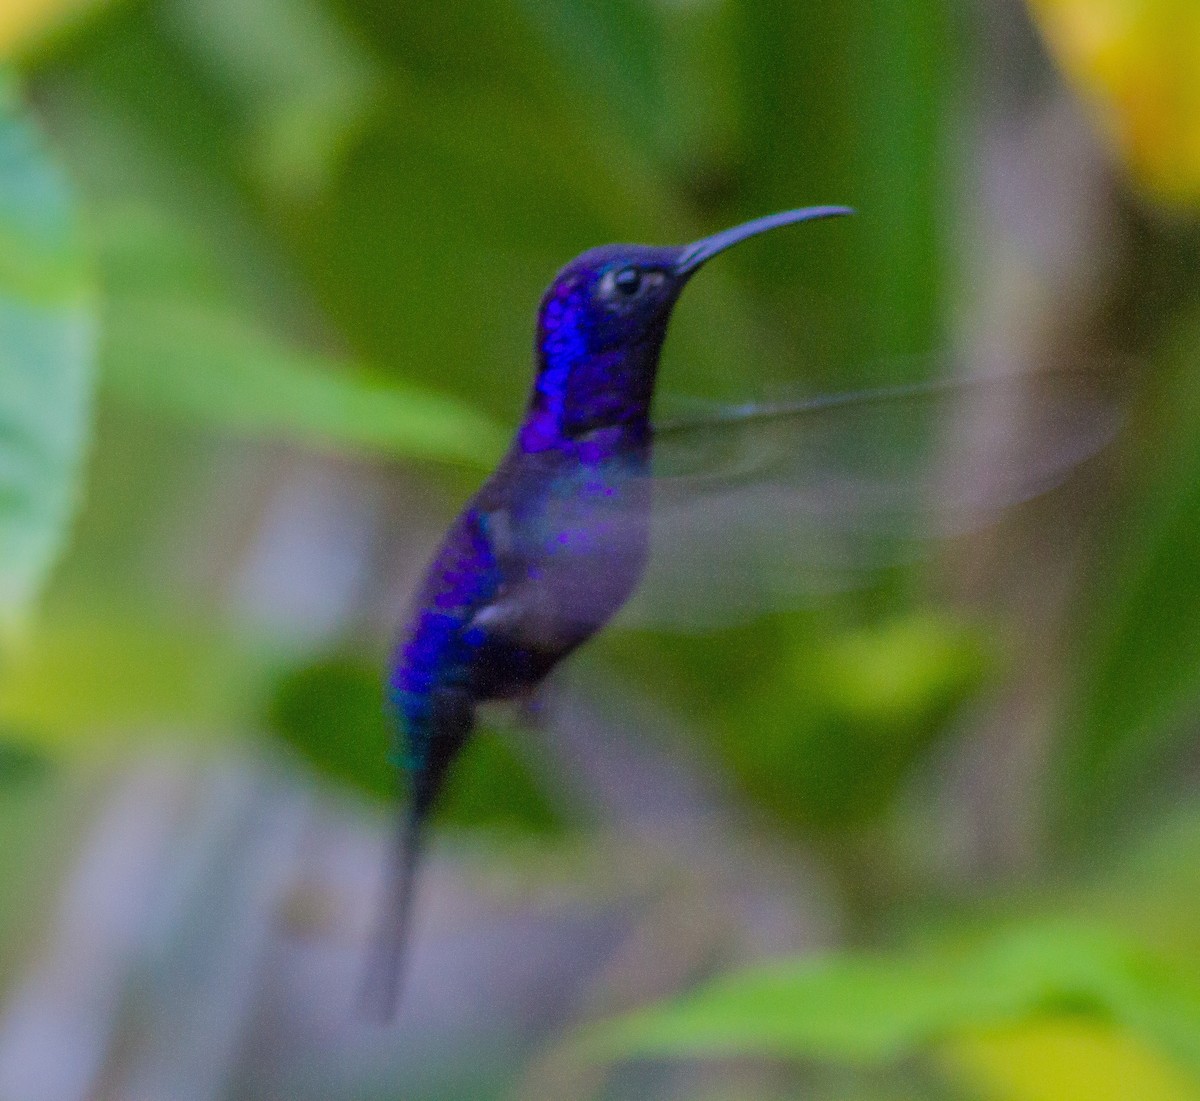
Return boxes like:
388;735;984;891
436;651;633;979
360;783;433;1023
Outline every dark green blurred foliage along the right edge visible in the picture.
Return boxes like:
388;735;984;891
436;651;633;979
1060;312;1200;830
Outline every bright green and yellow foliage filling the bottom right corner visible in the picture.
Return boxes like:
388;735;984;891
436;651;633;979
600;811;1200;1101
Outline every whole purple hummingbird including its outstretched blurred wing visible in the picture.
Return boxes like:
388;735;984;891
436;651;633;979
366;206;1111;1016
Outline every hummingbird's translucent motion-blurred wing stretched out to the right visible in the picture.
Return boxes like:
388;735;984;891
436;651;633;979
619;375;1120;628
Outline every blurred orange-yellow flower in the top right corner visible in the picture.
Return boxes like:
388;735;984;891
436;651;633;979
1030;0;1200;203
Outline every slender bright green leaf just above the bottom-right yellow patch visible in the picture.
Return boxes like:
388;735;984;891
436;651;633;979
589;922;1200;1071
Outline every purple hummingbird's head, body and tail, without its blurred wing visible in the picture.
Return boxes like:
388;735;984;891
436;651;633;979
365;206;853;1017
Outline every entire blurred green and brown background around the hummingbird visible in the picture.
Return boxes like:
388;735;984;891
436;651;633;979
0;0;1200;1101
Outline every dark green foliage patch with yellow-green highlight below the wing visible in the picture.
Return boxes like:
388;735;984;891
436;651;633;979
602;610;996;836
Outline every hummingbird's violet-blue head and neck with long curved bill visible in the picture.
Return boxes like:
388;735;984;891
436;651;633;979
522;206;851;450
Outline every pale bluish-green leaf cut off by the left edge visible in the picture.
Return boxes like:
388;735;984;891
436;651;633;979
0;73;95;631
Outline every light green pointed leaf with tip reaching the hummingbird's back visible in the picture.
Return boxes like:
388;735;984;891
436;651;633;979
94;212;504;465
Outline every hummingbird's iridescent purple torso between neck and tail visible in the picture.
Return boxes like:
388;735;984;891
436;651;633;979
391;425;650;759
